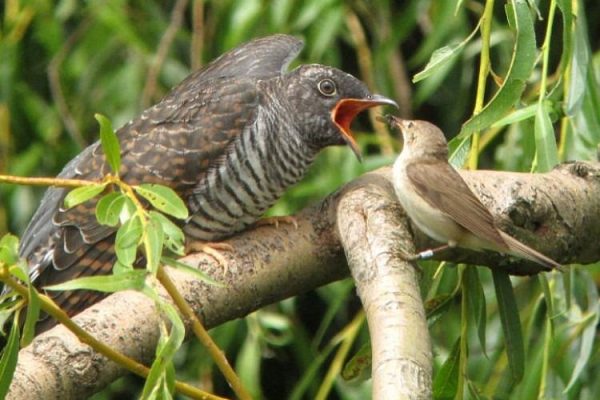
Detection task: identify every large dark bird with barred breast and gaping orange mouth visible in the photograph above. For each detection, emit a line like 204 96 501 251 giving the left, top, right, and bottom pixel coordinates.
14 35 395 331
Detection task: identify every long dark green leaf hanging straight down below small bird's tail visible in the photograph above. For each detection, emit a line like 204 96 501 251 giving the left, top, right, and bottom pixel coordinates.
492 269 525 383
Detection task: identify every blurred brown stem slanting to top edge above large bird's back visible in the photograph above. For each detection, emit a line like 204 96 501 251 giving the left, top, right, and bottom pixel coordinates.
142 0 188 108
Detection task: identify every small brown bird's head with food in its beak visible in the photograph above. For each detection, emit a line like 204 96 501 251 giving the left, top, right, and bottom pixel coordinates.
384 115 448 160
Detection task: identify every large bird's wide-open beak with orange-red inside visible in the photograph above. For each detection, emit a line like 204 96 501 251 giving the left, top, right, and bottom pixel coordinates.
331 94 398 160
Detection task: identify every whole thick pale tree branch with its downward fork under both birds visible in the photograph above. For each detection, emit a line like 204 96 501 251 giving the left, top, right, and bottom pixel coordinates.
9 163 600 399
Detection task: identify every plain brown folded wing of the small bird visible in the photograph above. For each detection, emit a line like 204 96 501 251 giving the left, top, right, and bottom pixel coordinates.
406 161 506 248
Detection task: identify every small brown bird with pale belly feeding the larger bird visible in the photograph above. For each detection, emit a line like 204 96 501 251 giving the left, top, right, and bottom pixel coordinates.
388 116 561 269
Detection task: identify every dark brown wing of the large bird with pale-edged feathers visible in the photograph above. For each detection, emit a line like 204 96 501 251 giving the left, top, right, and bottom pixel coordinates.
20 35 302 330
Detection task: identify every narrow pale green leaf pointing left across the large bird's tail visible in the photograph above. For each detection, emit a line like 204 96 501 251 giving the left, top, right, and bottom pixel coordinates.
44 269 148 293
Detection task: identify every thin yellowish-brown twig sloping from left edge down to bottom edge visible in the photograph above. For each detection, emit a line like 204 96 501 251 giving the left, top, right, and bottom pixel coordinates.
0 266 223 400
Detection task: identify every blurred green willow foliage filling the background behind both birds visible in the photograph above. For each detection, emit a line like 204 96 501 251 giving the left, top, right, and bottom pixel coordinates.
0 0 600 399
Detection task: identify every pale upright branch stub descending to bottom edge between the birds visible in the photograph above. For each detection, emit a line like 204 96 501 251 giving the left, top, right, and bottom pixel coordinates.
338 174 433 400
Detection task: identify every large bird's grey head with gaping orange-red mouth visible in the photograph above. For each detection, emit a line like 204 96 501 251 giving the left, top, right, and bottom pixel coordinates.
284 64 398 159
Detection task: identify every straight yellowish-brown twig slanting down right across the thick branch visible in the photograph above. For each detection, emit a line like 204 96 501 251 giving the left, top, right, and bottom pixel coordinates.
157 267 252 400
